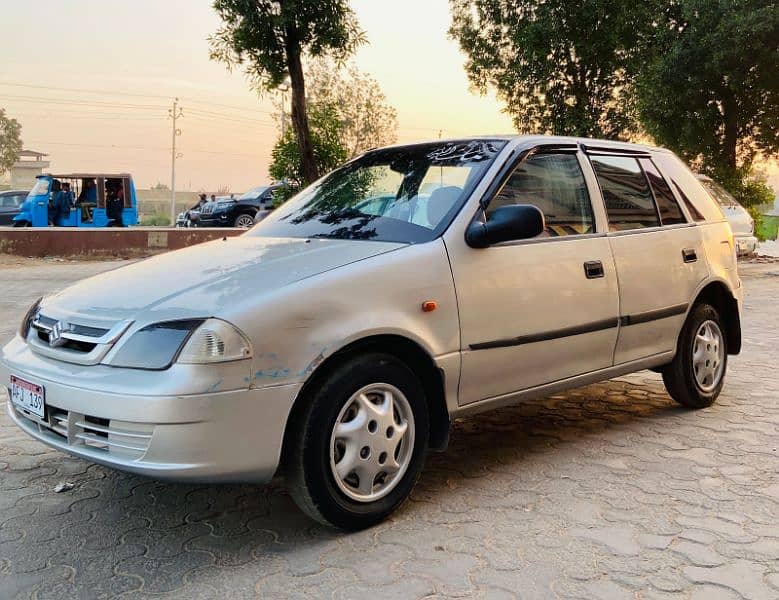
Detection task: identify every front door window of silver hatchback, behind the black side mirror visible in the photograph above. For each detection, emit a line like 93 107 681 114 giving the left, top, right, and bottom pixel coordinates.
486 154 595 237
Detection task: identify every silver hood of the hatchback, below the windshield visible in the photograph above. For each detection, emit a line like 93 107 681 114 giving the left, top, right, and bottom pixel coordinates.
41 235 404 326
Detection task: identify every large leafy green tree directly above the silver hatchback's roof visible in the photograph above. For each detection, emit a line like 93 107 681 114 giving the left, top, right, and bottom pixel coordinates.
449 0 652 138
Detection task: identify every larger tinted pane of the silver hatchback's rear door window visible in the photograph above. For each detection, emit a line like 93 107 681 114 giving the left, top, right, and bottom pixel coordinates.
590 156 660 231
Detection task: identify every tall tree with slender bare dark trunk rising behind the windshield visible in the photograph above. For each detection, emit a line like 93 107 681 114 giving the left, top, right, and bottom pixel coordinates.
209 0 365 182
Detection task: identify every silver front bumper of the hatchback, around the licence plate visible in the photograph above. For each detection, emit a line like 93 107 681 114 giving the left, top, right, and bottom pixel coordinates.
0 338 301 482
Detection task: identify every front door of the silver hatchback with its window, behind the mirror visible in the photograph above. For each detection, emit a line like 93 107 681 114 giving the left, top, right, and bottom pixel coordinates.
449 152 619 404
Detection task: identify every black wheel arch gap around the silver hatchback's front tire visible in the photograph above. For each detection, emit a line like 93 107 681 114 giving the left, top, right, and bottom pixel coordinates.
282 334 450 456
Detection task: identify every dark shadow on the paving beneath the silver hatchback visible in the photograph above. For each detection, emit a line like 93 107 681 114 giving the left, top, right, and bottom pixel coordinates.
0 373 682 591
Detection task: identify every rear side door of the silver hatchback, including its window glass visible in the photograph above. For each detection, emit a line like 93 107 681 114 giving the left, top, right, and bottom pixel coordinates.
589 154 707 364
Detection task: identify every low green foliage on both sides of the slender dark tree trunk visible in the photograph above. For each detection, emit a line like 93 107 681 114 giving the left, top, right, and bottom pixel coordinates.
268 102 348 190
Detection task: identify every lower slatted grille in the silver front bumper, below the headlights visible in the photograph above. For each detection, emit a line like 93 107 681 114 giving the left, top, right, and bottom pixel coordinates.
12 405 154 460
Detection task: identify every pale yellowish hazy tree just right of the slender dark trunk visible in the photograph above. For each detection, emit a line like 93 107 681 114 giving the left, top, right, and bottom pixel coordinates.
306 59 398 157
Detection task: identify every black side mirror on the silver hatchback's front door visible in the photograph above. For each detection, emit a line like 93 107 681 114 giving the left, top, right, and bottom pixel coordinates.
465 204 546 248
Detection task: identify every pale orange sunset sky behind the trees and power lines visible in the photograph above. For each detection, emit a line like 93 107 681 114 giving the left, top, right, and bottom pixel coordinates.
0 0 779 191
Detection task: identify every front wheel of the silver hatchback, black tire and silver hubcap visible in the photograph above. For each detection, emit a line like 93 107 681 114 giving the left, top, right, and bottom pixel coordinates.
282 353 429 531
